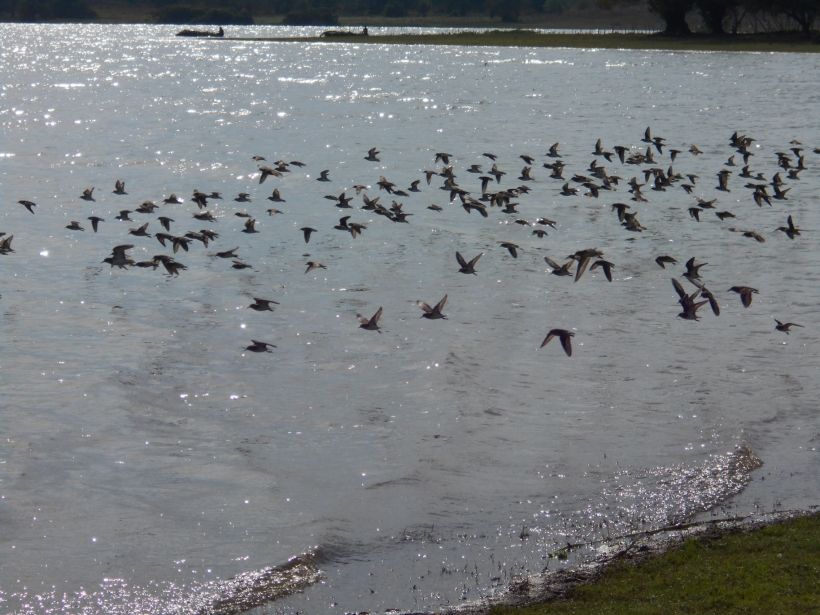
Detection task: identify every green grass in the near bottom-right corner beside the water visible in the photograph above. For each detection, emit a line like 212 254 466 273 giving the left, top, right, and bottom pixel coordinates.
490 516 820 615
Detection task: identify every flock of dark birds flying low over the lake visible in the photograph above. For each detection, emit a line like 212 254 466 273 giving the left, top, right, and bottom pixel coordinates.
0 128 820 356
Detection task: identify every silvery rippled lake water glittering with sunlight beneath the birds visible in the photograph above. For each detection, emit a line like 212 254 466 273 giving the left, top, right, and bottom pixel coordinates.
0 24 820 615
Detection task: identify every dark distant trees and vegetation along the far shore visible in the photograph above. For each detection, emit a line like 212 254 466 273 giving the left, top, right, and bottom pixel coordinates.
0 0 820 37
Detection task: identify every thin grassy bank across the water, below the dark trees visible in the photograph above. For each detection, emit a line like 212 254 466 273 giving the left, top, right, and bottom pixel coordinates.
240 30 820 53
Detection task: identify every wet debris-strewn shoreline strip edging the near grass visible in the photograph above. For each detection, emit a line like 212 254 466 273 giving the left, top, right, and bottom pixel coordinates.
454 510 820 615
